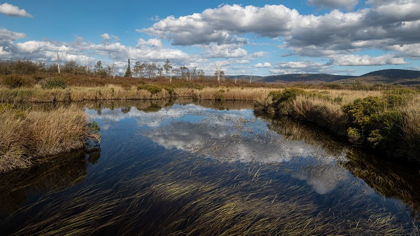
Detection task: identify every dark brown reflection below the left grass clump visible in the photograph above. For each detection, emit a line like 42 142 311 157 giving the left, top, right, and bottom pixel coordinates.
0 148 100 213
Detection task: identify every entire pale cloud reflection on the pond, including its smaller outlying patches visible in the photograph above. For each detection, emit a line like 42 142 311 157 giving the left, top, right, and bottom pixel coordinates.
88 104 349 194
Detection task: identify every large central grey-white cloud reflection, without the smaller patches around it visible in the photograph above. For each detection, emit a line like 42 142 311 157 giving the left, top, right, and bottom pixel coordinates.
145 114 344 166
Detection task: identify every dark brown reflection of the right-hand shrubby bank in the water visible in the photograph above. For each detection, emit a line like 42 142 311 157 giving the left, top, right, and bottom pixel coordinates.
260 114 420 223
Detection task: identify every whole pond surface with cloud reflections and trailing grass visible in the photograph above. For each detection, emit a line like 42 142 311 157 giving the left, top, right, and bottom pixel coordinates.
0 101 420 235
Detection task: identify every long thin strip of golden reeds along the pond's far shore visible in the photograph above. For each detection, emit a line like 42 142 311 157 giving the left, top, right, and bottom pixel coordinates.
0 84 273 103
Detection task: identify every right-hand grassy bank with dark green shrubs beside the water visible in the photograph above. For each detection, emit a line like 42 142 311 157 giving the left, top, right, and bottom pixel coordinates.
255 88 420 163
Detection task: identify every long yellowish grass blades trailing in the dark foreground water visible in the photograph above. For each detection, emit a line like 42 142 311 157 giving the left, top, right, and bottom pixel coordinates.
4 148 418 235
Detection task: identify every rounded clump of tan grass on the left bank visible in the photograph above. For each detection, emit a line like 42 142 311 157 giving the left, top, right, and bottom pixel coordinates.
0 104 99 173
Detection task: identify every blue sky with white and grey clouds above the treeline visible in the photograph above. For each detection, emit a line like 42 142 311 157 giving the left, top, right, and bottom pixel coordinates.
0 0 420 76
